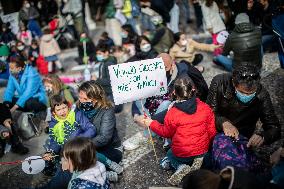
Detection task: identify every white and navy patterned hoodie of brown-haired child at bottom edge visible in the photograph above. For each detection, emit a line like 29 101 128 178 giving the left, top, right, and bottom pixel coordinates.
68 161 110 189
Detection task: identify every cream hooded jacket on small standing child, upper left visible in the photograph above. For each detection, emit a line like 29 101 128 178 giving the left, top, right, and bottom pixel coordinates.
39 34 60 57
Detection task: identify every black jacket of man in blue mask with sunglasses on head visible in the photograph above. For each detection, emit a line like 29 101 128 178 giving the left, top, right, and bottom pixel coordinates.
207 74 280 144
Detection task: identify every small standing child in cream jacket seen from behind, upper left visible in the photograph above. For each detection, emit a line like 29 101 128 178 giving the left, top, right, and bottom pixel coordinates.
39 28 64 73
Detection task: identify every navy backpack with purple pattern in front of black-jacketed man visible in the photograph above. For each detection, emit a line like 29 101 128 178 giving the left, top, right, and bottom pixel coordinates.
212 133 262 172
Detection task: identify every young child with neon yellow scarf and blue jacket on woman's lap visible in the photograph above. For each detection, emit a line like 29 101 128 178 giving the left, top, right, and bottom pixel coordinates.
44 95 123 181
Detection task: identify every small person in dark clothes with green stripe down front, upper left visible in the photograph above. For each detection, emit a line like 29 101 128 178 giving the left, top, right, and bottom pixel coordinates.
78 33 96 64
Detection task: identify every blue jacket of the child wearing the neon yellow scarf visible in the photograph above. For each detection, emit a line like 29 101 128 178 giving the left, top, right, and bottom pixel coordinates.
46 111 96 154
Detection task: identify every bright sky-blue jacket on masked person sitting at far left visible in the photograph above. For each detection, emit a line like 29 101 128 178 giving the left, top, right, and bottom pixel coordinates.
3 65 47 107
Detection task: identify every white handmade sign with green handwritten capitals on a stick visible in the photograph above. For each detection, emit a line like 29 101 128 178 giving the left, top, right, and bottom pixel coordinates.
108 58 167 105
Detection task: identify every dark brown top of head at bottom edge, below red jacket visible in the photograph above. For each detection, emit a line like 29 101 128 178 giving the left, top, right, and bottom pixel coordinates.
182 169 221 189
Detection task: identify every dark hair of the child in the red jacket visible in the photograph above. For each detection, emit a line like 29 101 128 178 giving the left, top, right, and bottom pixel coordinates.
173 75 195 100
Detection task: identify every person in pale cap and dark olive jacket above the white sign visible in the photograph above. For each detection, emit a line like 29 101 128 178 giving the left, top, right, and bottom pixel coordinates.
151 15 175 53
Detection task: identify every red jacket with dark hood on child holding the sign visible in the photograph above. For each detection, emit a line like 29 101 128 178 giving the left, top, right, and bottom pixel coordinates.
150 98 216 157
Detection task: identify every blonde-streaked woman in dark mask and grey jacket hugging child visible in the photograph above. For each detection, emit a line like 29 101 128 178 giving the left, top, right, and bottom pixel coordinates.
78 81 122 163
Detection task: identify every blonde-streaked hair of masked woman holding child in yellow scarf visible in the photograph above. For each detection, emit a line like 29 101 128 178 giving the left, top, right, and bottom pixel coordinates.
78 81 113 109
